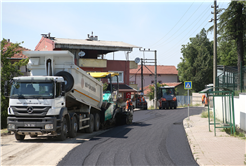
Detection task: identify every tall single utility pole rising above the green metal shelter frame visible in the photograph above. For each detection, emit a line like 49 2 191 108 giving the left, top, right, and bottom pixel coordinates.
209 0 219 87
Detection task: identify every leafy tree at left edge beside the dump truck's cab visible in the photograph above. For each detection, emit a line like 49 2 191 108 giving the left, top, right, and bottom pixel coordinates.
0 39 28 127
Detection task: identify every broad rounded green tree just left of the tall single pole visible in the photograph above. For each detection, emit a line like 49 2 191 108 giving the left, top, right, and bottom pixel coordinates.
178 28 213 92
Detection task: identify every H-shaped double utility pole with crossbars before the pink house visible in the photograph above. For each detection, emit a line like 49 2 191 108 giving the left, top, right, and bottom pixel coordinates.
139 48 157 109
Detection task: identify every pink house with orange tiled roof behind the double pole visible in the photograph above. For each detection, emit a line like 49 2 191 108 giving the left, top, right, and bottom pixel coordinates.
130 65 178 89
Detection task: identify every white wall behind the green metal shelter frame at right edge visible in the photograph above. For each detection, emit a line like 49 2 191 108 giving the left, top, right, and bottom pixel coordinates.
215 94 246 131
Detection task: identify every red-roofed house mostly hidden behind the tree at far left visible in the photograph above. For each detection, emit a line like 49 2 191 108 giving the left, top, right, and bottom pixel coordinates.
0 39 31 76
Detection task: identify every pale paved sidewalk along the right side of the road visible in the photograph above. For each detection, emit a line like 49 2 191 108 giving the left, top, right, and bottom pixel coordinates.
183 115 246 165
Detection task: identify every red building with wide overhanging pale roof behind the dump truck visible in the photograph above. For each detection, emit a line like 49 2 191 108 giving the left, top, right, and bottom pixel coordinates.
35 33 139 98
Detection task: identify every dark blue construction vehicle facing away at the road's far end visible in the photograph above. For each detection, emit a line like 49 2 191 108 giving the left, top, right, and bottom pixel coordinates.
158 86 177 109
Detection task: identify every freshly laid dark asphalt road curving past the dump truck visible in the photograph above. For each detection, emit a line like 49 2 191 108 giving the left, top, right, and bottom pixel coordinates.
58 107 203 166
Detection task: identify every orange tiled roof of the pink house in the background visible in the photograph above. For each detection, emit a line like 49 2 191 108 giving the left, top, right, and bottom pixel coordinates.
130 65 178 75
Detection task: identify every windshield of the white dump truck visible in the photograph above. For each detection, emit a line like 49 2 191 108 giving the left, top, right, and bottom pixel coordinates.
10 82 54 99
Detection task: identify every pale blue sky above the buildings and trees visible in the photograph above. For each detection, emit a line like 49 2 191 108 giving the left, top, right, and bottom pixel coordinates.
0 0 230 67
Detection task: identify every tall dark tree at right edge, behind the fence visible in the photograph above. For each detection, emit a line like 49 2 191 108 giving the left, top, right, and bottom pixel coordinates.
209 0 246 88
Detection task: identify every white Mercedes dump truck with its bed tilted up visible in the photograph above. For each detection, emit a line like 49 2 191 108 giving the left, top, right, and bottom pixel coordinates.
5 51 132 140
